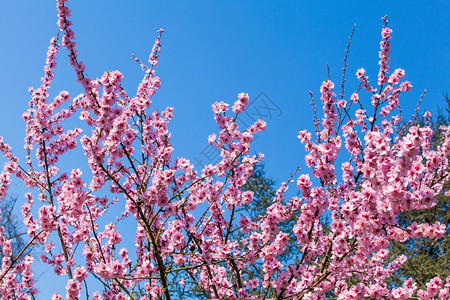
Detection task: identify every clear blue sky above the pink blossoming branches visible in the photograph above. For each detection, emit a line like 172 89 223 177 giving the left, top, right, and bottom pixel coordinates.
0 0 450 299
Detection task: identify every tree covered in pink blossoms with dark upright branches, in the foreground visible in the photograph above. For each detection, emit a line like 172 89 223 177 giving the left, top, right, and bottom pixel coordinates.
0 0 450 299
